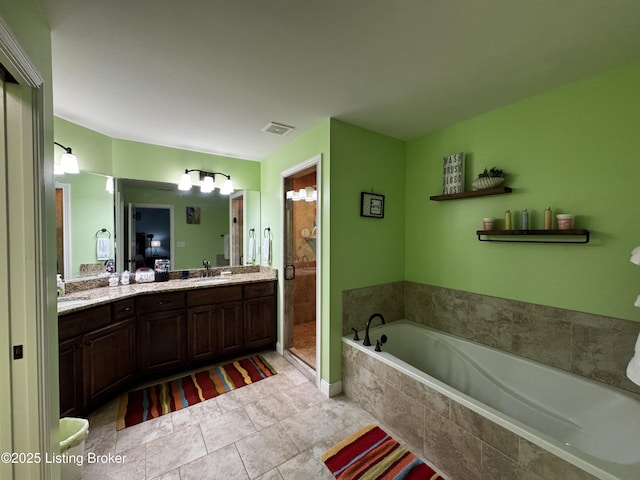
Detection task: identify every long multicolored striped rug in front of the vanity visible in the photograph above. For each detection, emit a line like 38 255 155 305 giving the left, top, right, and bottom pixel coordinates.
116 355 277 430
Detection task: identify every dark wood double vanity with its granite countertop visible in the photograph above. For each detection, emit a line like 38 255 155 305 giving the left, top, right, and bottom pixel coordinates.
58 267 277 416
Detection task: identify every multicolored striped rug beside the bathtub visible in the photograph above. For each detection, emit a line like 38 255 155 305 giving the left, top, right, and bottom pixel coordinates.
322 425 442 480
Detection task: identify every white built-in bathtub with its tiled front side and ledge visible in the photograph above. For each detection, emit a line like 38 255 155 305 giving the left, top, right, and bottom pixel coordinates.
343 321 640 480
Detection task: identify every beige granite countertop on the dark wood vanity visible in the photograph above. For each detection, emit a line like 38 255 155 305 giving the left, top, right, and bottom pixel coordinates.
58 267 278 314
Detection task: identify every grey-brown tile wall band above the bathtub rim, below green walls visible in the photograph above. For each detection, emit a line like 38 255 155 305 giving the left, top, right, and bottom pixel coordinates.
342 282 640 393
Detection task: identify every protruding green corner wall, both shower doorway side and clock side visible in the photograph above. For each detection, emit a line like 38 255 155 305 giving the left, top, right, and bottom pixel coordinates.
261 119 405 383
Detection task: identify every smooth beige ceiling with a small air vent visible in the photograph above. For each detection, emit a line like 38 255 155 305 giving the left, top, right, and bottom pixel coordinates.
39 0 640 160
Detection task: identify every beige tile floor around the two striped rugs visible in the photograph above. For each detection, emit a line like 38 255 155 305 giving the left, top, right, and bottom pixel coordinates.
82 352 430 480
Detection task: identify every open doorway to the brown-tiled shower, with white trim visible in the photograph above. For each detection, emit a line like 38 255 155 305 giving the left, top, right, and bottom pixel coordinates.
282 156 321 383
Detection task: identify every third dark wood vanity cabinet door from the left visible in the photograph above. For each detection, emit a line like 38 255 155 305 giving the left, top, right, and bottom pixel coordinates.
138 310 187 374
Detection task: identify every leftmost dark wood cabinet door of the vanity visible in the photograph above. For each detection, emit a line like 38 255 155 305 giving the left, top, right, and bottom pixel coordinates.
58 337 83 417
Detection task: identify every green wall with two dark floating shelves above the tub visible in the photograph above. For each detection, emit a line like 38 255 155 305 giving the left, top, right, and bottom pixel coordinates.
405 63 640 320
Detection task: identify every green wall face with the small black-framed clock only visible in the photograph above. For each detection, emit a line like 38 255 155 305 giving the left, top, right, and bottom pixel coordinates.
330 120 405 382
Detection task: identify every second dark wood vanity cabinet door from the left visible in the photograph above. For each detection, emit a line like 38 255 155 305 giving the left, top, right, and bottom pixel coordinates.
82 319 135 405
